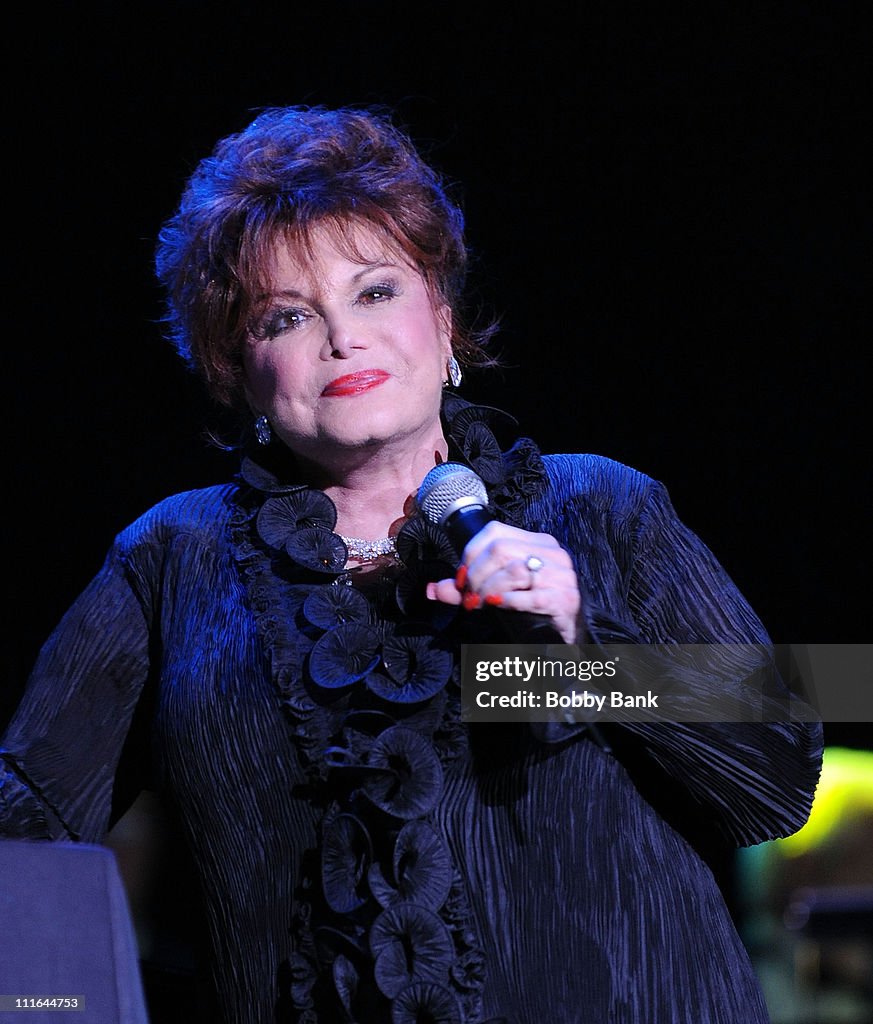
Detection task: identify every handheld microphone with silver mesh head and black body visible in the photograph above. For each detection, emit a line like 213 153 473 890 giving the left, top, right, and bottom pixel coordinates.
416 462 564 643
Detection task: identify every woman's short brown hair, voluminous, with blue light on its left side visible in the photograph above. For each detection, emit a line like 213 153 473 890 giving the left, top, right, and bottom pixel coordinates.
156 106 493 406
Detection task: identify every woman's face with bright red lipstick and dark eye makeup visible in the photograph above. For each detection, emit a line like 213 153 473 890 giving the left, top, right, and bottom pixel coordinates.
244 224 451 465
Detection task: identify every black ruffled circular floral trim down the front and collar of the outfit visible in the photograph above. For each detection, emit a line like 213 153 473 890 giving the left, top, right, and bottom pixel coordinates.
231 396 545 1024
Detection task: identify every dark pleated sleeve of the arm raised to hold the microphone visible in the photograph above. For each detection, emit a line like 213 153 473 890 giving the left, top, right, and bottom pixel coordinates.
532 456 822 846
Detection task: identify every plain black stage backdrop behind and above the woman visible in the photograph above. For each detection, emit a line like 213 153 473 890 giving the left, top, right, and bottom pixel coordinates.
0 0 871 753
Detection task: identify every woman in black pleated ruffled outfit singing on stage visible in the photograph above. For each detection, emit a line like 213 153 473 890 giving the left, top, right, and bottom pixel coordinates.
0 108 821 1024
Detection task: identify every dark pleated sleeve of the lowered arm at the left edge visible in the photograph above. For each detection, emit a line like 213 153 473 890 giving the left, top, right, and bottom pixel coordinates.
0 542 150 843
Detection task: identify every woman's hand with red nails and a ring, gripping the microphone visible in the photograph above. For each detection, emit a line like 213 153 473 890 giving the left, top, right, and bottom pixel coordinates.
427 522 582 643
